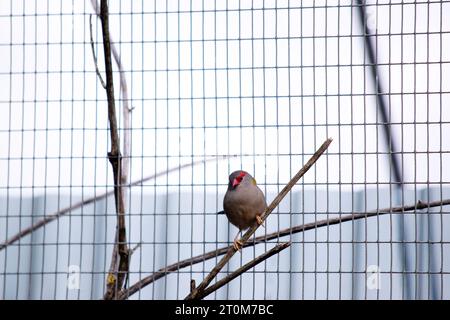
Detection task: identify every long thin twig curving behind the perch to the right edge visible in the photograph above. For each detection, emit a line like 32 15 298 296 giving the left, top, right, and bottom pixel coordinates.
119 199 450 299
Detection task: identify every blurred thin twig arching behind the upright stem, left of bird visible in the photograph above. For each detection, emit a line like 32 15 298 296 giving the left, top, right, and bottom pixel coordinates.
0 155 232 251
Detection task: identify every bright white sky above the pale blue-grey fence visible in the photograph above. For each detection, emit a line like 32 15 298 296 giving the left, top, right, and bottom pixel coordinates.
0 0 450 193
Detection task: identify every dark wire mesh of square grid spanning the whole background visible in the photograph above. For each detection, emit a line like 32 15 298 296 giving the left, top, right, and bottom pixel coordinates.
0 0 450 299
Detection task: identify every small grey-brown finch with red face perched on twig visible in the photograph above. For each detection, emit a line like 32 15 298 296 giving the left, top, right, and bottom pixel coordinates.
223 170 267 251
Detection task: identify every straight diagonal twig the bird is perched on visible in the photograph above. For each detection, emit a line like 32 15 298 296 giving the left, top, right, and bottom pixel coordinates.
186 138 333 300
